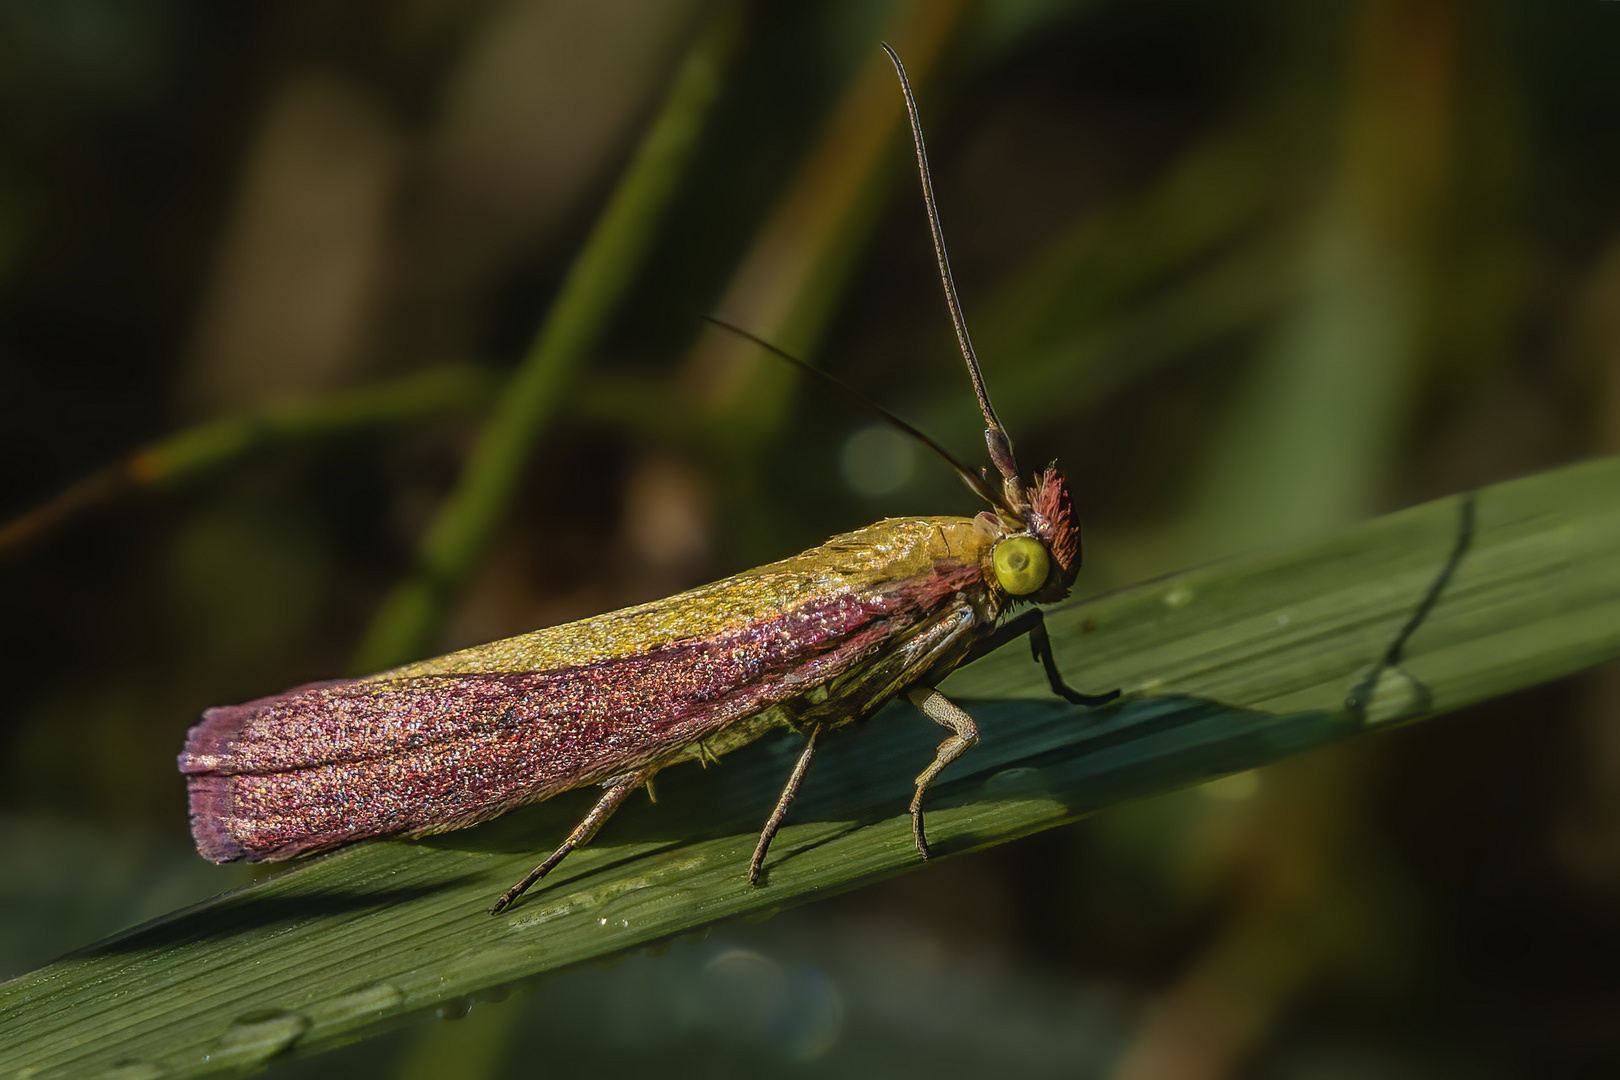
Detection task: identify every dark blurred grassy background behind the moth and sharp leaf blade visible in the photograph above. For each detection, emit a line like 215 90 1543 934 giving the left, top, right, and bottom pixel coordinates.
0 0 1620 1080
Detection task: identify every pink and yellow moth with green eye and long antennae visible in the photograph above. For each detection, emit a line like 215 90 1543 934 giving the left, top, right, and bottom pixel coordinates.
180 45 1116 913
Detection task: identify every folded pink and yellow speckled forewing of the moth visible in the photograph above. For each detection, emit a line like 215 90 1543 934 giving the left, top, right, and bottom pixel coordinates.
180 518 993 861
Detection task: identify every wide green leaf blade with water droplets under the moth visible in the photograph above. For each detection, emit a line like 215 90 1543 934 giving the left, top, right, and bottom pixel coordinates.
0 458 1620 1077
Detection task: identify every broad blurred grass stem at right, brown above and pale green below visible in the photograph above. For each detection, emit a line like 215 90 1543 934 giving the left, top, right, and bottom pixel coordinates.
1181 0 1458 559
